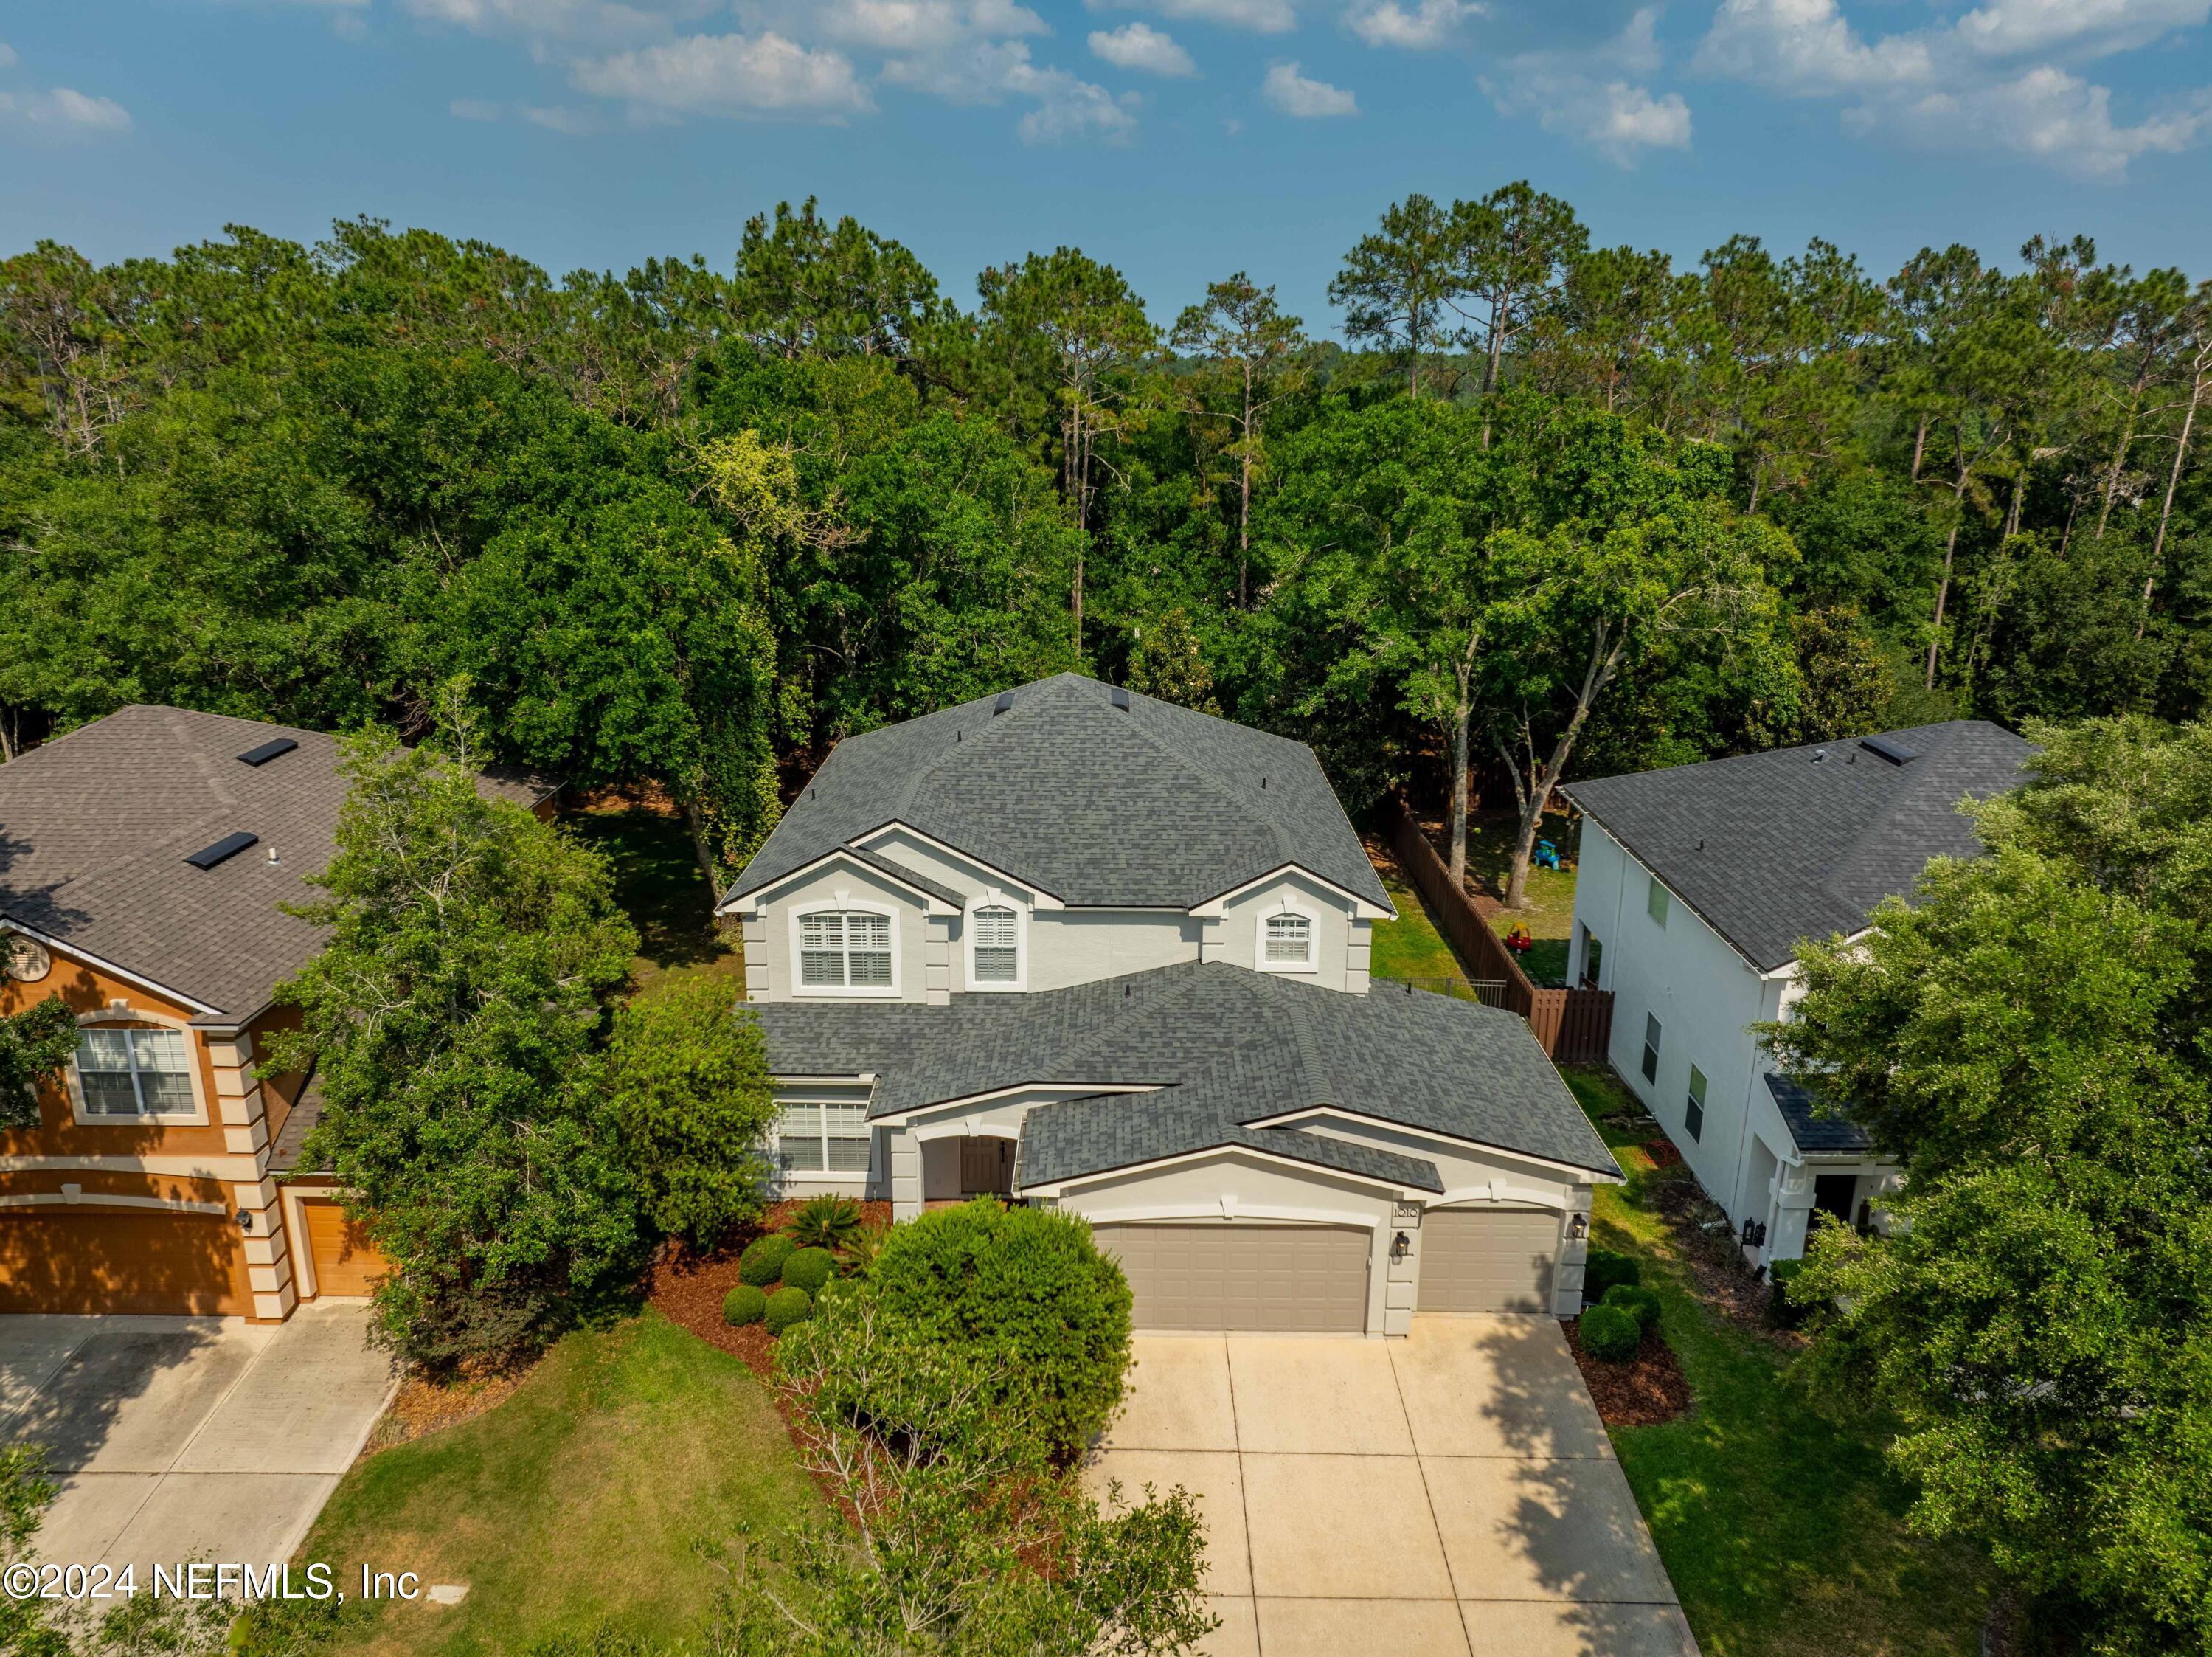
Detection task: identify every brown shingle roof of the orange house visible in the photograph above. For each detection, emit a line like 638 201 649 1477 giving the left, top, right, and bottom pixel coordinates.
0 706 555 1017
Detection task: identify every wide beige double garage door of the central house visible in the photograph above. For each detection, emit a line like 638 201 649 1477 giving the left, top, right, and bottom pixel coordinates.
1098 1221 1369 1334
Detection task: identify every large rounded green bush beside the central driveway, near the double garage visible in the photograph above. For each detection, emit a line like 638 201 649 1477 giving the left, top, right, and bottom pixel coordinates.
870 1201 1130 1456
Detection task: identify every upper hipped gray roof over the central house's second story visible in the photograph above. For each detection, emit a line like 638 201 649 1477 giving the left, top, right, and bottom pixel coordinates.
728 673 1389 909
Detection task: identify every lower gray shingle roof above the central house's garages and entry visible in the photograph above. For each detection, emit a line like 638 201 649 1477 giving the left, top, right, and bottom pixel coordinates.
748 962 1615 1183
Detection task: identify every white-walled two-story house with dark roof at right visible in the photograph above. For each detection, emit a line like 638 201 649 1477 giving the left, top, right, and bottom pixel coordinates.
1561 719 2031 1261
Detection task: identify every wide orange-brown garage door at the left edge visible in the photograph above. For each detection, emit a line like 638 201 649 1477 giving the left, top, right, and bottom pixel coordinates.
0 1208 254 1316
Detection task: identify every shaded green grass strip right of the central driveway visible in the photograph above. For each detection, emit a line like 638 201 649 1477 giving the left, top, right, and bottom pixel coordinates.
1566 1070 1991 1657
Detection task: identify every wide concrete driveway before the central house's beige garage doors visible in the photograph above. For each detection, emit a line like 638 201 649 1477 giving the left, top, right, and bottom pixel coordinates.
1089 1316 1696 1657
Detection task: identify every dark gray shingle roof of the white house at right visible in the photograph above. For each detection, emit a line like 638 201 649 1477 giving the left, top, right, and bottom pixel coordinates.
1561 719 2033 971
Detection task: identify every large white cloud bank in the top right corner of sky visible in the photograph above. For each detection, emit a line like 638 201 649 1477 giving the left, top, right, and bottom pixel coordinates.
1696 0 2212 179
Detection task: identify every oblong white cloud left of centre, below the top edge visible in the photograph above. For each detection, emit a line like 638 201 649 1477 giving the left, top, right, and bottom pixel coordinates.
571 33 874 122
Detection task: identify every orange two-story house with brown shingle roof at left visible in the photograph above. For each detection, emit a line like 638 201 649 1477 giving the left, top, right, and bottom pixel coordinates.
0 706 551 1321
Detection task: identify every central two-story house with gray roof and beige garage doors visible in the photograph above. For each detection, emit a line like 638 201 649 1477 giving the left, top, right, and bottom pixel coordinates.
721 675 1617 1334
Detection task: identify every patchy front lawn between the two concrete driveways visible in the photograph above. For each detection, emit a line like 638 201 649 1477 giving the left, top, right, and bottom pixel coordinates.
303 1310 821 1657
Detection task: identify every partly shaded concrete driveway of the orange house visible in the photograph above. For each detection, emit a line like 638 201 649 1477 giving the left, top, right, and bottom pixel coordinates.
0 1301 398 1580
